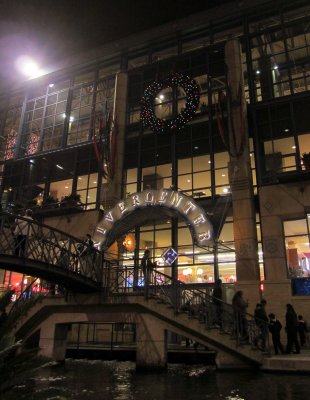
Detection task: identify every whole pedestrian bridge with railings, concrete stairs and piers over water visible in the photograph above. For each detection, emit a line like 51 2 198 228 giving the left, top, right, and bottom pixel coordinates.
0 213 272 365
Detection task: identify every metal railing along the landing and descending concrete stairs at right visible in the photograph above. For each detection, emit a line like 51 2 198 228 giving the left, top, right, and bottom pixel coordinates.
103 266 270 353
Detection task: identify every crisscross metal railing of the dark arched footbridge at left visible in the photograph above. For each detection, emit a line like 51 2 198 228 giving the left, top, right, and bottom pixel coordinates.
0 213 106 283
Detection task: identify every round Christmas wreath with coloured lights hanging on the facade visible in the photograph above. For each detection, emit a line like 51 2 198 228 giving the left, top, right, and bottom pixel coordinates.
141 73 199 133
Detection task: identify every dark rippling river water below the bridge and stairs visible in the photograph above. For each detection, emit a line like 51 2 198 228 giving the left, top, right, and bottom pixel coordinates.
1 359 310 400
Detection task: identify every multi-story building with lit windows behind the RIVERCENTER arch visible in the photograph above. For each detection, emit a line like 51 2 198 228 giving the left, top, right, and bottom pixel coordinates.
1 0 310 318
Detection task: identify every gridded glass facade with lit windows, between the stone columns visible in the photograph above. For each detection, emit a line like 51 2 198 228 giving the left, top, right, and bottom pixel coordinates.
1 0 310 290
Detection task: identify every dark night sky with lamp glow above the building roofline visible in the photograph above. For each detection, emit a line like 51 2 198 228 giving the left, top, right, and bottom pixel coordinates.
0 0 228 83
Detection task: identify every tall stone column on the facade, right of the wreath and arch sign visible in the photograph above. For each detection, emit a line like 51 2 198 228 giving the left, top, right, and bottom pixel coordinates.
225 39 260 304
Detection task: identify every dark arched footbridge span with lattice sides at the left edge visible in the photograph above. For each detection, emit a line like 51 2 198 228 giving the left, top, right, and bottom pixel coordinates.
0 213 108 293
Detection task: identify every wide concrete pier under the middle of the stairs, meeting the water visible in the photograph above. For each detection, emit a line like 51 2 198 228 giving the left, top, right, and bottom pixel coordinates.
136 314 167 370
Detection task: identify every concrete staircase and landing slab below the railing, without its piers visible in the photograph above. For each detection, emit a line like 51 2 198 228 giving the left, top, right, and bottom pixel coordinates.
10 293 266 368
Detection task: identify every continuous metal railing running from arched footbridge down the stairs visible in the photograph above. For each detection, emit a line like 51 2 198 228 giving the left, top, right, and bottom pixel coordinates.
0 213 270 352
